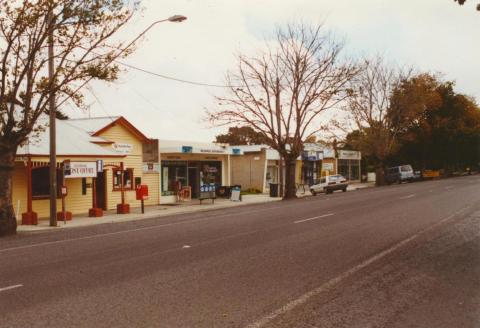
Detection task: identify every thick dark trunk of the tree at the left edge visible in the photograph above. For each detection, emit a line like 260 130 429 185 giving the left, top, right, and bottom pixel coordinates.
0 148 17 237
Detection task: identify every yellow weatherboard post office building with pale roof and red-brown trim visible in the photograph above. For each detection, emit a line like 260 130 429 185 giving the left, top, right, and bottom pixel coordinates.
13 117 159 224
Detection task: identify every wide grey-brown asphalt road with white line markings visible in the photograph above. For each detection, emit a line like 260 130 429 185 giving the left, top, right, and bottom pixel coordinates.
0 176 480 328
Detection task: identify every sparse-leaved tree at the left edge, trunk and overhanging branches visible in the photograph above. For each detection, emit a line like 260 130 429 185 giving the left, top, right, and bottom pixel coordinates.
0 0 137 235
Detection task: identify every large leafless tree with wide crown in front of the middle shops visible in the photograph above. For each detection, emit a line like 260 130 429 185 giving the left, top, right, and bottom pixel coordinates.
208 24 357 198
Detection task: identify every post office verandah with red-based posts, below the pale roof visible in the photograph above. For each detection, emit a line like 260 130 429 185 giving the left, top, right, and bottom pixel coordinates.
13 156 133 224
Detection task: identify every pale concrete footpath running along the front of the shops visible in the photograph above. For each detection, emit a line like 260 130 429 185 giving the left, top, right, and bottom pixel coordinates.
17 183 374 233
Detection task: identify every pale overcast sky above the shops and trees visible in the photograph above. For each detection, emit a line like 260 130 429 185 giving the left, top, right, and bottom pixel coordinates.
64 0 480 141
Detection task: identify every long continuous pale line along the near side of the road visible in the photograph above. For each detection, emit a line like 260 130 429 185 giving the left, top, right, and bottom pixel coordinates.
247 205 472 328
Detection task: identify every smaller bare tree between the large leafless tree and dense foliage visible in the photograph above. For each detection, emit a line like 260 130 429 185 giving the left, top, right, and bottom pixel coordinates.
335 56 411 184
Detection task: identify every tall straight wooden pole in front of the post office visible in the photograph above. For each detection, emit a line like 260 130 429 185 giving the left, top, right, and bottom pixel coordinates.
47 9 57 227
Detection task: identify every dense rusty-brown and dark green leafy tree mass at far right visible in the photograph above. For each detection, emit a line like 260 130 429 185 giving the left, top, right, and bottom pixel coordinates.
392 74 480 172
